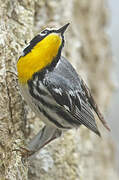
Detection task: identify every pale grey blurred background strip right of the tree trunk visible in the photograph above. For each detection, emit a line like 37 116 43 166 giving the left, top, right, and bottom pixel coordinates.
108 0 119 170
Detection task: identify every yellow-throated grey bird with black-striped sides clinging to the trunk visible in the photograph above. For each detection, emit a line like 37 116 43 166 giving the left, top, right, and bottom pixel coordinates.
17 23 110 155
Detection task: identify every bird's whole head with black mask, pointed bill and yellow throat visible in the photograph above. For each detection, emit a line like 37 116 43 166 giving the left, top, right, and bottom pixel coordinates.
17 23 69 83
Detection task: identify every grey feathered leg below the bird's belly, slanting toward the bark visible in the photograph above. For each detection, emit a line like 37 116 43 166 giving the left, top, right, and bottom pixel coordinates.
27 126 62 156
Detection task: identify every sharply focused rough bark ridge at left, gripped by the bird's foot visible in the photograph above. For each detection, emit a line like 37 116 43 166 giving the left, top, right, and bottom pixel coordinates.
0 0 34 180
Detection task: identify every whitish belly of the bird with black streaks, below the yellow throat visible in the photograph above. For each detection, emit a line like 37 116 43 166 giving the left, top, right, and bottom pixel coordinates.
20 85 73 129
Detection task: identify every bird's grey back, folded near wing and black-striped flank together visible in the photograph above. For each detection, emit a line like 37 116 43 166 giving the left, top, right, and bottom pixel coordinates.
28 57 100 135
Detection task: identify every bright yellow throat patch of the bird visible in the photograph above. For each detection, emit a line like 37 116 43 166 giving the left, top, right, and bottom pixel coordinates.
17 33 62 84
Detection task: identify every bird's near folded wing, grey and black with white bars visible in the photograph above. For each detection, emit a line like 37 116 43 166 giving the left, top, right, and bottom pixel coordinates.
45 72 100 136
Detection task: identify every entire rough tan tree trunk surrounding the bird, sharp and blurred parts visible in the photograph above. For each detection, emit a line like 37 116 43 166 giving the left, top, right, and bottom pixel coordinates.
0 0 118 180
